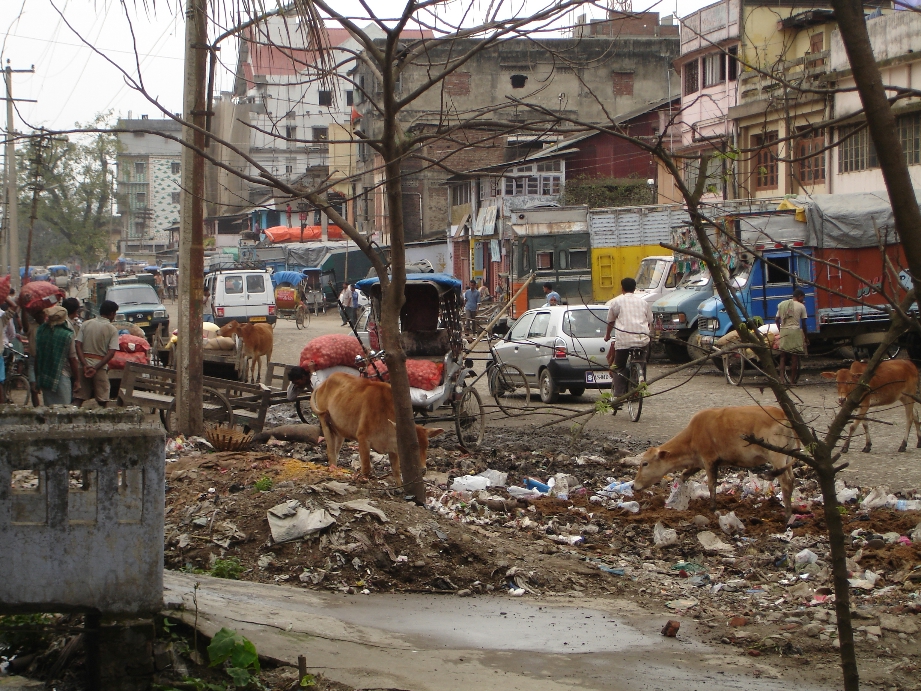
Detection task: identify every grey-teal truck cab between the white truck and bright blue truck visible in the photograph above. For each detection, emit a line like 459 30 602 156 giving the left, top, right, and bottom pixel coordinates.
652 267 713 362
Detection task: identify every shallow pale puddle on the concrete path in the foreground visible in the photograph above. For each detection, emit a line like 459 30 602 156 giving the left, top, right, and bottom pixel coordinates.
325 595 661 653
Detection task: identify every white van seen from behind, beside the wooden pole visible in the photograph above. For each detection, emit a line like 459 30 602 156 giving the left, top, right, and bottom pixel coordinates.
205 268 277 326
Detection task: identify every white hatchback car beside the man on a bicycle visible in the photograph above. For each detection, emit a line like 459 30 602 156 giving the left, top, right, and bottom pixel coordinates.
495 305 614 403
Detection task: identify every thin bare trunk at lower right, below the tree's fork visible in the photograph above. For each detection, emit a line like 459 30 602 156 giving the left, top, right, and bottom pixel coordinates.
816 464 860 691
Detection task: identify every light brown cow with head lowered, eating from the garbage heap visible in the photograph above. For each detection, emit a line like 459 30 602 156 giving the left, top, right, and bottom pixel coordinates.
633 406 798 519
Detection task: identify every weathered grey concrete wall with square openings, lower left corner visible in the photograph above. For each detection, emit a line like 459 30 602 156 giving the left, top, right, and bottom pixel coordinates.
0 406 164 615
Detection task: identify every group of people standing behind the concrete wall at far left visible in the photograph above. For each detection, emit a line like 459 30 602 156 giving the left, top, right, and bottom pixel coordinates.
0 293 119 407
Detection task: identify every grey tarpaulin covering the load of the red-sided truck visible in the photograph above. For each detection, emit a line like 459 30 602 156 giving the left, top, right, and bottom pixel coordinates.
795 190 904 249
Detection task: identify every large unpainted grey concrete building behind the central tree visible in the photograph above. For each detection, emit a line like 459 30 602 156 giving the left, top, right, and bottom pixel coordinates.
354 12 678 244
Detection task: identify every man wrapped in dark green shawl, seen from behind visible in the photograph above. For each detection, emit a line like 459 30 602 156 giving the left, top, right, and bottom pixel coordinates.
35 305 78 405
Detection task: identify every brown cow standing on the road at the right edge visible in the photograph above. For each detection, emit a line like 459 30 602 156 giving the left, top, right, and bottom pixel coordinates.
822 360 921 453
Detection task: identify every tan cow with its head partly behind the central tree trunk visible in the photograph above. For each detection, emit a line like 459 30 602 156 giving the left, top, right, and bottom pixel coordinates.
310 372 444 485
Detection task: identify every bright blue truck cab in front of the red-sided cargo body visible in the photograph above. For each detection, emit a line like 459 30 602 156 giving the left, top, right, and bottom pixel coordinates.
700 247 818 348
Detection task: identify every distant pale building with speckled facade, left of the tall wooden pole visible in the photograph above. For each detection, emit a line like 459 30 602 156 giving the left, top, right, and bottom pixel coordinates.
116 112 182 256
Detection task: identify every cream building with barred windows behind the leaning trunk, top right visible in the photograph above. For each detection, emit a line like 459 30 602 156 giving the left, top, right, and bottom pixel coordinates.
828 11 921 194
